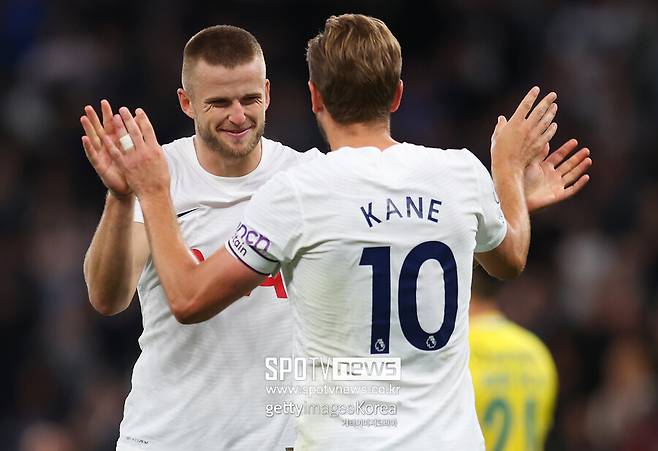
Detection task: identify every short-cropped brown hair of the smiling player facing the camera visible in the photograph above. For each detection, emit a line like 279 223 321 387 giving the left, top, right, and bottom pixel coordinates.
182 25 263 87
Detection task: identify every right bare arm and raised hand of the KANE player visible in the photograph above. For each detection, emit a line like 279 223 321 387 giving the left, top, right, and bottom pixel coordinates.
475 87 557 279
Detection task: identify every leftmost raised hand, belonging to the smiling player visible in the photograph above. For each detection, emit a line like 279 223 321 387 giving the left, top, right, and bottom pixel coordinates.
80 100 132 197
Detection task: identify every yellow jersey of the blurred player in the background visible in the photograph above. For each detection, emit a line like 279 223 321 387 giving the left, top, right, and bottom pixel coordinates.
470 313 557 451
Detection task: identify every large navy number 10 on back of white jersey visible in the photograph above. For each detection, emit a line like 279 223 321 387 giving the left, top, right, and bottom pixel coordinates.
359 241 457 354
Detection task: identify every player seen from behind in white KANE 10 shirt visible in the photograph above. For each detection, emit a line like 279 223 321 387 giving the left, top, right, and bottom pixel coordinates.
105 15 586 450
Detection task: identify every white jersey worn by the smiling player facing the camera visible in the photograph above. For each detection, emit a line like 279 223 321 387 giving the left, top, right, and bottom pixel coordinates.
117 137 321 451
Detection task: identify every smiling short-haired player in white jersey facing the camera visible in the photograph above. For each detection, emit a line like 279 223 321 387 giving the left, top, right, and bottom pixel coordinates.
82 26 319 451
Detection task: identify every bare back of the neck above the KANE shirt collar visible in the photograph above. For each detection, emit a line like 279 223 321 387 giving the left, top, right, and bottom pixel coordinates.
324 121 398 150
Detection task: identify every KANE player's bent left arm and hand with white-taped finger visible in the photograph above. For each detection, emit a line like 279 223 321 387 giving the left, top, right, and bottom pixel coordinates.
99 108 267 323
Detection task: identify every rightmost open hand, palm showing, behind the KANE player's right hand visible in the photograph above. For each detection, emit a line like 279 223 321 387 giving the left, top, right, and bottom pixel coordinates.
524 139 592 212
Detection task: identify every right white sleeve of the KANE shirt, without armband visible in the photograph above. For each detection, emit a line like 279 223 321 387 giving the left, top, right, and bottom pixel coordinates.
469 152 507 253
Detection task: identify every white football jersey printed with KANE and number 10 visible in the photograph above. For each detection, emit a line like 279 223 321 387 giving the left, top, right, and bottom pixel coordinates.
226 143 507 451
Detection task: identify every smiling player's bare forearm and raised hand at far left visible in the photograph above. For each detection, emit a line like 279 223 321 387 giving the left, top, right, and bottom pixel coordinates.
80 100 149 315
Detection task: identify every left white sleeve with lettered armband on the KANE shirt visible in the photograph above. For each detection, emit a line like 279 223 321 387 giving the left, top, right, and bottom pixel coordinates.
225 173 302 274
